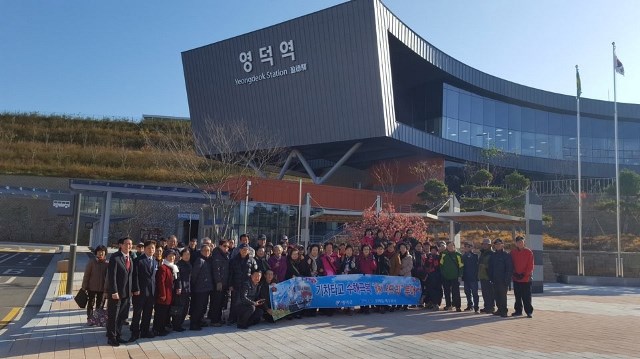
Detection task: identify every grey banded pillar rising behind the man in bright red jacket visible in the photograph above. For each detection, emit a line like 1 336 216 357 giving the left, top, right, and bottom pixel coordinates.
524 191 544 293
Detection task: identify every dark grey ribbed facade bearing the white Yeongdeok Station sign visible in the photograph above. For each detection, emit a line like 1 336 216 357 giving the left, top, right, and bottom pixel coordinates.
182 1 385 151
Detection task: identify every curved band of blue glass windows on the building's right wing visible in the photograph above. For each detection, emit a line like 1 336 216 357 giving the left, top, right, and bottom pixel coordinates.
442 84 640 163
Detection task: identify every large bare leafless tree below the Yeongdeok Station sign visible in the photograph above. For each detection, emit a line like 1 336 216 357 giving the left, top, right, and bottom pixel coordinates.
142 121 282 238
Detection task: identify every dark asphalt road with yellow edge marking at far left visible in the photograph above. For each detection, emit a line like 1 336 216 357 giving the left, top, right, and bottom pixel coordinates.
0 251 53 329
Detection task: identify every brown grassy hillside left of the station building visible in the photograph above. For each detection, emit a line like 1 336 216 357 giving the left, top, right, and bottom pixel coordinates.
0 113 195 182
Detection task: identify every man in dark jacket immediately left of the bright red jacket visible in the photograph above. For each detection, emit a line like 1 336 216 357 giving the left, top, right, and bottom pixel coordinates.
489 238 513 318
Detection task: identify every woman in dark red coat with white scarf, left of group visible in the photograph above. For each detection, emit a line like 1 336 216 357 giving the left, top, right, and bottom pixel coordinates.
153 249 180 336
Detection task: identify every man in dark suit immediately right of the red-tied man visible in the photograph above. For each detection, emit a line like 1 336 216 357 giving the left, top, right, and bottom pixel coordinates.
129 241 158 342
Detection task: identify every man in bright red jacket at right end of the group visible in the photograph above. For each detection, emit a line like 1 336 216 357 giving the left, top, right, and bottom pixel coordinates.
510 236 534 318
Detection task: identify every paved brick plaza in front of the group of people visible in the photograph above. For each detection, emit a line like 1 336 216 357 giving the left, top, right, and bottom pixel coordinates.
0 253 640 359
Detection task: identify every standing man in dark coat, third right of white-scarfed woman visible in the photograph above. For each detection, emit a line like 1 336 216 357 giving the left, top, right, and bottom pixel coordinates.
208 239 229 327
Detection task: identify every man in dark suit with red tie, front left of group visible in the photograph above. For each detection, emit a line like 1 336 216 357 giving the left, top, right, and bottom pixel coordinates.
107 237 133 347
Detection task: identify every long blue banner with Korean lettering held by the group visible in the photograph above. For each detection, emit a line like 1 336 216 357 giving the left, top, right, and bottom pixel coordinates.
270 274 422 319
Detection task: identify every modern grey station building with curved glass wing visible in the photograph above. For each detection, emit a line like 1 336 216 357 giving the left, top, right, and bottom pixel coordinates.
182 0 640 240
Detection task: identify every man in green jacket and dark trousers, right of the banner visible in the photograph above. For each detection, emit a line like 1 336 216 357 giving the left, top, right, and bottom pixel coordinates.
440 241 464 312
